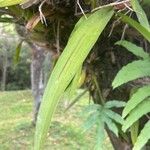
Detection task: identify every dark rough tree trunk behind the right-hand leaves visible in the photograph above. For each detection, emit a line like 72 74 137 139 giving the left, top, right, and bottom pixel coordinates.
85 35 137 150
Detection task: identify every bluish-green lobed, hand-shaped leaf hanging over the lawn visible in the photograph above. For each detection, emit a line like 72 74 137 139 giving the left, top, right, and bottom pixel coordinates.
83 101 125 150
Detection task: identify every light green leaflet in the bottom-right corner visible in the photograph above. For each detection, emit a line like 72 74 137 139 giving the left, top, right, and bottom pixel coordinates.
133 121 150 150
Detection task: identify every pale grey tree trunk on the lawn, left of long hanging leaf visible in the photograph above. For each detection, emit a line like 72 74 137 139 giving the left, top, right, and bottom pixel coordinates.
29 43 45 124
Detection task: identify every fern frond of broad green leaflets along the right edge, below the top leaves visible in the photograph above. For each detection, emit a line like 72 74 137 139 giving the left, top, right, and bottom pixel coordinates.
112 41 150 150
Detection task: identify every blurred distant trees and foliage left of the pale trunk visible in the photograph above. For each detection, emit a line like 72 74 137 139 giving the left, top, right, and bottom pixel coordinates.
0 23 31 90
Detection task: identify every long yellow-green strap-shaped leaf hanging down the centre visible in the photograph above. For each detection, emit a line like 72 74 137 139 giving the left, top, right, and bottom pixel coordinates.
34 8 113 150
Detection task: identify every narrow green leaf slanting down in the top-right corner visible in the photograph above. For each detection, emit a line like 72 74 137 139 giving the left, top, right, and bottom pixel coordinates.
131 0 150 31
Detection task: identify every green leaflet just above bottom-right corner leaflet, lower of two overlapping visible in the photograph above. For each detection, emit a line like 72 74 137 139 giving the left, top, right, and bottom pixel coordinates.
122 99 150 131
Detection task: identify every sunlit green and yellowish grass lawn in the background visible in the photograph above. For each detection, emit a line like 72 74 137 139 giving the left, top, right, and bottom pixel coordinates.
0 91 112 150
